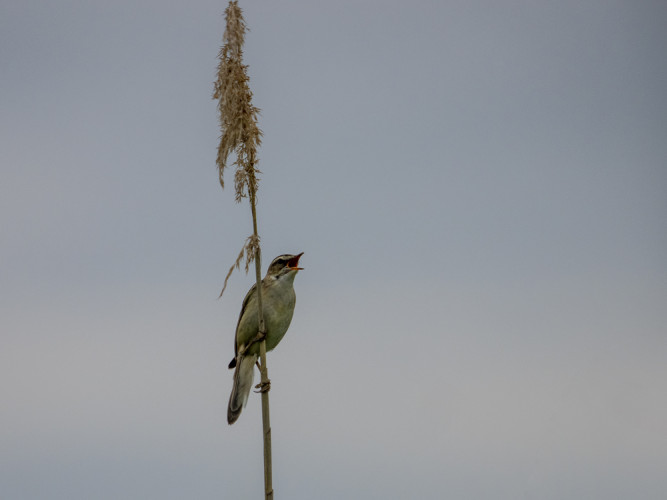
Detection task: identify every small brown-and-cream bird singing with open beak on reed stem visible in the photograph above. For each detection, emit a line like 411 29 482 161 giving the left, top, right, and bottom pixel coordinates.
227 252 303 425
